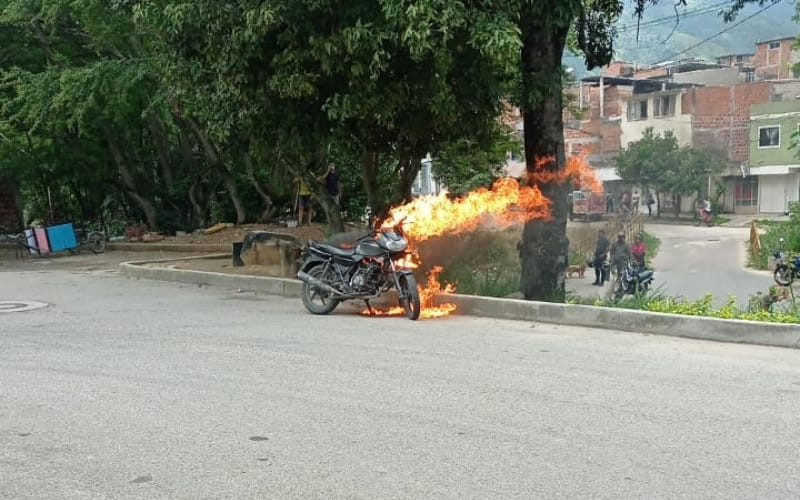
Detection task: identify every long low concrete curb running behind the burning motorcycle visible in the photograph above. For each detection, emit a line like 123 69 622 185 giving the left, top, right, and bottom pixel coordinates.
120 255 800 348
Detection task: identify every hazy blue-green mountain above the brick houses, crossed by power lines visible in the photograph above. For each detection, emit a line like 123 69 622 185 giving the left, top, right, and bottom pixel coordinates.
564 0 800 77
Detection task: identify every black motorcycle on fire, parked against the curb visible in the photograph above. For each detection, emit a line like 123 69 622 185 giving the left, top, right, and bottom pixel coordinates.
297 223 421 320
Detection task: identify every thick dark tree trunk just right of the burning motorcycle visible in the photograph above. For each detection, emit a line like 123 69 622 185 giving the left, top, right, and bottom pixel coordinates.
519 21 569 302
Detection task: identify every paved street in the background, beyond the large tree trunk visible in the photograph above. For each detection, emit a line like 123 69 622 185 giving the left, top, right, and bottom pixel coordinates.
567 224 774 307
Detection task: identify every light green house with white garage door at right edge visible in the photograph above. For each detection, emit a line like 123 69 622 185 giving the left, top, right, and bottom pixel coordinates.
734 100 800 213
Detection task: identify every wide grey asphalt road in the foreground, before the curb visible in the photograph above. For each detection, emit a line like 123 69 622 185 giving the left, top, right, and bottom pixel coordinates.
0 260 800 499
